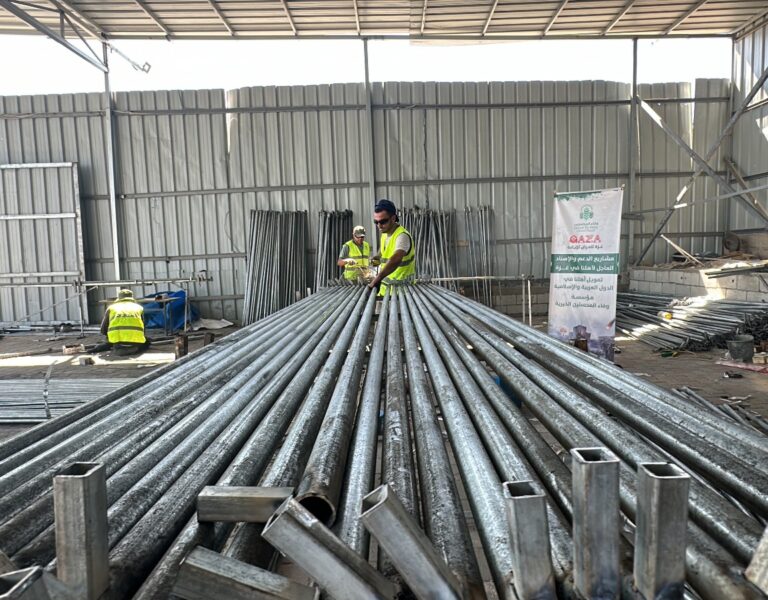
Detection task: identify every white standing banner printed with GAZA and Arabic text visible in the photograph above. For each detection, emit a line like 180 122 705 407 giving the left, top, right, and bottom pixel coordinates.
549 188 624 360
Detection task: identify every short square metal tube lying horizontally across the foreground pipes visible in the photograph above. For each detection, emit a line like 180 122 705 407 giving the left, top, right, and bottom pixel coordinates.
197 485 293 523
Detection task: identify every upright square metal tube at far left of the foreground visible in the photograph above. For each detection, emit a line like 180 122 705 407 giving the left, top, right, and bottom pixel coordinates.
53 463 109 600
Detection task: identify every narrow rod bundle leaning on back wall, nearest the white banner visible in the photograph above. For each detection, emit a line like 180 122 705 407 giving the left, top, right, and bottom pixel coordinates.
464 206 496 306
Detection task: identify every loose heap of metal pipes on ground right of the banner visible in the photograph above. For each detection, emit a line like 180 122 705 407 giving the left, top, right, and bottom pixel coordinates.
616 292 768 352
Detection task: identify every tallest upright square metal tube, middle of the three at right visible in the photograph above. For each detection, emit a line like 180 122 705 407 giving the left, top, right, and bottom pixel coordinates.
571 448 621 600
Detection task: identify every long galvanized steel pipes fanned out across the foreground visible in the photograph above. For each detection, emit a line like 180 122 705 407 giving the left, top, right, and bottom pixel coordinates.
0 284 768 600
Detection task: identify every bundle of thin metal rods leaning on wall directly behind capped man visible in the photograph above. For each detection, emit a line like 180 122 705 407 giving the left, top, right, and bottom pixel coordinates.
400 207 457 287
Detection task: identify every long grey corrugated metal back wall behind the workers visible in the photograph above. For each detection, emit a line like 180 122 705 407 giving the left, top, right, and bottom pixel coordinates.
0 80 728 320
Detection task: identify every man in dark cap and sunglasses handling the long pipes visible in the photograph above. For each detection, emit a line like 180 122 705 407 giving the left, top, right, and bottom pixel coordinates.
368 200 416 296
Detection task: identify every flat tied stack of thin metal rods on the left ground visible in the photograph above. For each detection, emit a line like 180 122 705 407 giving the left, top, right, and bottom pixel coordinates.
0 377 133 423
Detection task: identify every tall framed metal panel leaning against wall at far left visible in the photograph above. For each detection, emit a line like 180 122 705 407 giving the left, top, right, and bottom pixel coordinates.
0 163 88 323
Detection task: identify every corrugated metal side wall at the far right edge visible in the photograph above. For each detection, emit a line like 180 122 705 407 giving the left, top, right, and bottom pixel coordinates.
729 25 768 230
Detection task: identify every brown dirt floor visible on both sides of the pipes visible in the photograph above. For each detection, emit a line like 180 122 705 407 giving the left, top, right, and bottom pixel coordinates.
0 323 768 440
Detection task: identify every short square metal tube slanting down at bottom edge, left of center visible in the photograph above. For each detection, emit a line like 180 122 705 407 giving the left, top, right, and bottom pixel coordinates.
173 546 319 600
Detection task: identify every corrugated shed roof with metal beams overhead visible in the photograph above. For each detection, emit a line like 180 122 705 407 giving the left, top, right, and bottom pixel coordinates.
0 0 768 39
